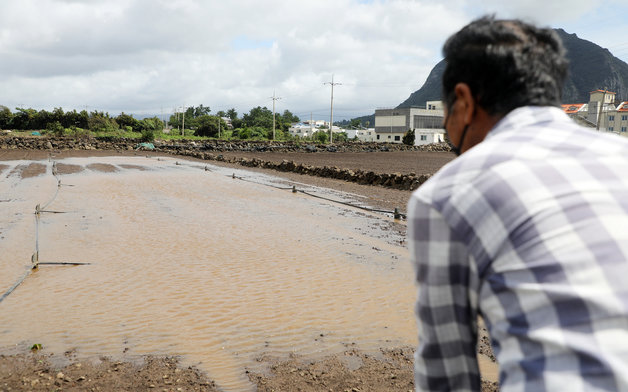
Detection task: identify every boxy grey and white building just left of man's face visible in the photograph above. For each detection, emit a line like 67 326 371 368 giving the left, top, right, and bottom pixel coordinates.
375 101 445 145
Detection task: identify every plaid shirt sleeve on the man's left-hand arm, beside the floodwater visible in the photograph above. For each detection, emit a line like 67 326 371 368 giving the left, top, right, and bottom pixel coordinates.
408 197 481 391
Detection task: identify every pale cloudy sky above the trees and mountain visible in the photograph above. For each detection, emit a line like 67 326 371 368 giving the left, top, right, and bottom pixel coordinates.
0 0 628 119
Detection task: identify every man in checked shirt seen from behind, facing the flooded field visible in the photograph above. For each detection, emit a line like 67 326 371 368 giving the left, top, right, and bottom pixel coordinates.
408 17 628 391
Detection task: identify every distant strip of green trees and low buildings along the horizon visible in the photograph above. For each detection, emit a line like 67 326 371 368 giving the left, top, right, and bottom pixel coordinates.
0 90 628 145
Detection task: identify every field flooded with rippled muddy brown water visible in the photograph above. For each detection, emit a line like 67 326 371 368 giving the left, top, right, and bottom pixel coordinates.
0 156 416 391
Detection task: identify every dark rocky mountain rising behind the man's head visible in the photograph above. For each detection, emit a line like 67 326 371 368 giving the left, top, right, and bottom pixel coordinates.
397 29 628 108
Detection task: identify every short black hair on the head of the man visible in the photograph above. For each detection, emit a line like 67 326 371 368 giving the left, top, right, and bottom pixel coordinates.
443 16 568 115
